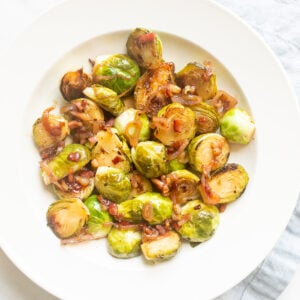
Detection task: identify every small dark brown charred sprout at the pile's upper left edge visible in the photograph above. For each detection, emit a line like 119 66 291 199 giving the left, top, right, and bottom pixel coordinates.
60 68 92 101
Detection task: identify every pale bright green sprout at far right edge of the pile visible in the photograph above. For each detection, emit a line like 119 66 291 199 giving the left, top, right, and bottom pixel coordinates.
220 107 255 144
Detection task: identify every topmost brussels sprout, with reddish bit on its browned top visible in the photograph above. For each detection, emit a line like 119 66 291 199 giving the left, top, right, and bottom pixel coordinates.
126 28 162 69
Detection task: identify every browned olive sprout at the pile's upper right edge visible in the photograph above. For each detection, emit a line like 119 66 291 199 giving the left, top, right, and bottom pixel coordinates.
176 62 217 101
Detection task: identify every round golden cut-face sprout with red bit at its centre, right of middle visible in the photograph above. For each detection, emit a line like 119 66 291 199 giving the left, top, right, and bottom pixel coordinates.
152 103 196 146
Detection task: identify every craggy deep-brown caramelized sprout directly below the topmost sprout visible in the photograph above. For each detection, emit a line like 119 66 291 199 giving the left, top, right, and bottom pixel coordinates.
134 63 175 117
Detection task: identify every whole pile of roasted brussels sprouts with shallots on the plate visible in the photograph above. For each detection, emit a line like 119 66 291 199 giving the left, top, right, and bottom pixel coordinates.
32 28 255 263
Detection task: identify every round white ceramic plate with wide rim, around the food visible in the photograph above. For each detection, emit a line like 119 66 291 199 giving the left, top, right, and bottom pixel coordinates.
0 0 300 299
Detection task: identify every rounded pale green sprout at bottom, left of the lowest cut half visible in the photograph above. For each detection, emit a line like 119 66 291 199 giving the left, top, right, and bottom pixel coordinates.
107 228 142 258
